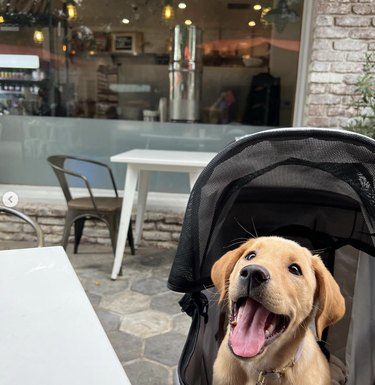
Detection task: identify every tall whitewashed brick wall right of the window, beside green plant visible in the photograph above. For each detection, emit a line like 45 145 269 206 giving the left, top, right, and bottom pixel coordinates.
305 0 375 127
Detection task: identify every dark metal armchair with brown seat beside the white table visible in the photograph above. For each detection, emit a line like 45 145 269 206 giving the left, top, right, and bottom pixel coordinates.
47 155 135 255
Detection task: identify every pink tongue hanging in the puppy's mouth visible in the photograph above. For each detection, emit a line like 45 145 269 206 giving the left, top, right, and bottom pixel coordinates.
230 298 270 357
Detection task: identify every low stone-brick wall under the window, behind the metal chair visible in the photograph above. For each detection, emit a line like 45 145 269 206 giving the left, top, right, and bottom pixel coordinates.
0 202 183 250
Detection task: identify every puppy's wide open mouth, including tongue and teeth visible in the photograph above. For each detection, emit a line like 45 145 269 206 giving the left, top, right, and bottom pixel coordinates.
229 298 289 357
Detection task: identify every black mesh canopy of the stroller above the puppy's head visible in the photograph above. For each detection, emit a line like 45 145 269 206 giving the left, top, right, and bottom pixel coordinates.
168 128 375 293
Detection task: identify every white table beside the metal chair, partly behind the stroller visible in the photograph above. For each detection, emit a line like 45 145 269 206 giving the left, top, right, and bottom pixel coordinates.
111 150 216 279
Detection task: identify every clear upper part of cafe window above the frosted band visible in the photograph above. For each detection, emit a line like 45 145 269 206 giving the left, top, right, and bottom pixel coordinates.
0 0 303 127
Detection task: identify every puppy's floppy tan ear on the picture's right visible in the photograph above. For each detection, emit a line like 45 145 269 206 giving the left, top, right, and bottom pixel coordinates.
313 255 345 339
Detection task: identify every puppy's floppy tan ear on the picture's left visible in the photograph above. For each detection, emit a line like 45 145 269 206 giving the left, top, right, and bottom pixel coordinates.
211 243 248 303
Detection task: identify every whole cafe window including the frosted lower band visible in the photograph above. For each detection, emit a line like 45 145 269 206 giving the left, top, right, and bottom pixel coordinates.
0 0 304 193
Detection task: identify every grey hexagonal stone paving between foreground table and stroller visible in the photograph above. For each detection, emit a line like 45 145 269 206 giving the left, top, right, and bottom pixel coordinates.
1 243 190 385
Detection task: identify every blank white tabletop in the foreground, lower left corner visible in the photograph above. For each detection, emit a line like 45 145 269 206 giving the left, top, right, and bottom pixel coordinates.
0 246 130 385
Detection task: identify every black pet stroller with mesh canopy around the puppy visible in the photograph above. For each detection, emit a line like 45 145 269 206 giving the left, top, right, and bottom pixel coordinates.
168 128 375 385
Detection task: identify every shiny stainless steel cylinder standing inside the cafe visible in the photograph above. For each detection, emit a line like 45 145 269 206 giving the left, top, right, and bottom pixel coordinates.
169 25 202 122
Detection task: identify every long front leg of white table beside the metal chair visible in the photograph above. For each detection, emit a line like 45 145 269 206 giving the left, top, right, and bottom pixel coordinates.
111 164 138 279
